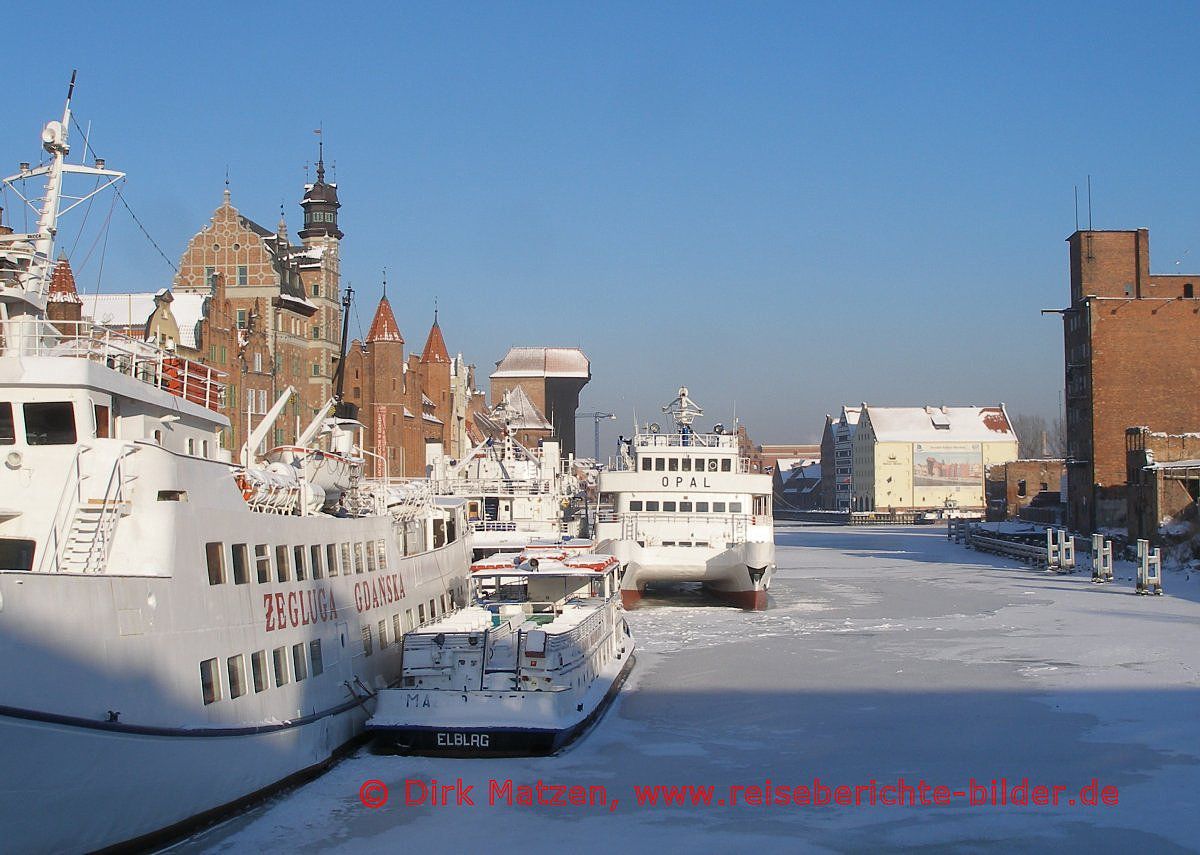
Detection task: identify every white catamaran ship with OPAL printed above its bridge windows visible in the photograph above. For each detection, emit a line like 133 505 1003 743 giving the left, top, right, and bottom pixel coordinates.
596 387 775 609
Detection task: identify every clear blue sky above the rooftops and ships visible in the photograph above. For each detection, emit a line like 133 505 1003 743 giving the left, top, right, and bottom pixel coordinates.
0 2 1200 449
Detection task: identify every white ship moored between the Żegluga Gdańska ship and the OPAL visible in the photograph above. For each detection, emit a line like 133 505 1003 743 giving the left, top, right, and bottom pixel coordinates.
428 402 586 558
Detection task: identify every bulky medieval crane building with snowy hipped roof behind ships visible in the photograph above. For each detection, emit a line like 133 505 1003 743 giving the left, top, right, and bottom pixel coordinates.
491 347 592 456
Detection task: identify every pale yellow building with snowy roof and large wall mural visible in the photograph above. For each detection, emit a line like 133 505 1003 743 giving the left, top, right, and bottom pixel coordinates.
852 403 1018 510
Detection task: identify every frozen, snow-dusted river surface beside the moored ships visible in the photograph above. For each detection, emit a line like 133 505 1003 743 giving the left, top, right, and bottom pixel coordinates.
172 526 1200 854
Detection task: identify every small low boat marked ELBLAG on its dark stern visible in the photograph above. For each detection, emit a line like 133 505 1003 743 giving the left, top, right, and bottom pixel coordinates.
366 542 634 757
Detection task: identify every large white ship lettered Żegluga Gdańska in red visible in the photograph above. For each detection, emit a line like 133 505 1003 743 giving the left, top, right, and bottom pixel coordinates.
0 80 469 853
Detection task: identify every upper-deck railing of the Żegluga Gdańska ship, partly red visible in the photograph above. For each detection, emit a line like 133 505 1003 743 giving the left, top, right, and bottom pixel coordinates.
0 319 226 411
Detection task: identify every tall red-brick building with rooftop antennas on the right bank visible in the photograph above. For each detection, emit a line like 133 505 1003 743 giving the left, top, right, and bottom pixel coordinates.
1062 228 1200 532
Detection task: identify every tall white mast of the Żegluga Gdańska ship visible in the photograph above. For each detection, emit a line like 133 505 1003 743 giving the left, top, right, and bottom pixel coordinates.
0 71 125 319
